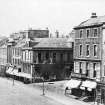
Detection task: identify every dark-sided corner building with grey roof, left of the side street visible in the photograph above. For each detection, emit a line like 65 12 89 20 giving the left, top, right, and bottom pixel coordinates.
22 38 73 82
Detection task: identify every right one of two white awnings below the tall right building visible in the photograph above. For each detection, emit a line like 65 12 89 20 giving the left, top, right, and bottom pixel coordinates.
80 80 97 91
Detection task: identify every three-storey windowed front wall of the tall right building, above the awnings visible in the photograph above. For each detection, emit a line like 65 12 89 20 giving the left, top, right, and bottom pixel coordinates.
74 26 102 79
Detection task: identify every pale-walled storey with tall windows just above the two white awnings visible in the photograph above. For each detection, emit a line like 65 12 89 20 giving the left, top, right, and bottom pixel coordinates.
74 59 101 79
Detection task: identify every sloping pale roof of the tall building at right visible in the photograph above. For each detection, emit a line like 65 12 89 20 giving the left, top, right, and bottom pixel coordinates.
74 16 105 29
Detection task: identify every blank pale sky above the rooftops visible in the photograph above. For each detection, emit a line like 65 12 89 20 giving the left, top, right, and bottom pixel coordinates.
0 0 105 36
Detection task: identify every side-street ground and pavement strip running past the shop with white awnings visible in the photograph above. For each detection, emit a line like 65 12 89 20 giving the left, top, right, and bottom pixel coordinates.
29 80 95 105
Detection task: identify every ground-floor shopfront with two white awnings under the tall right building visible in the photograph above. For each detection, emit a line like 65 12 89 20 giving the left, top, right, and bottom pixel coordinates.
66 73 97 101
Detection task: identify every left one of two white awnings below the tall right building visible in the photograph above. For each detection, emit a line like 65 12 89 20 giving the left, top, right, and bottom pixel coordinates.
66 79 81 89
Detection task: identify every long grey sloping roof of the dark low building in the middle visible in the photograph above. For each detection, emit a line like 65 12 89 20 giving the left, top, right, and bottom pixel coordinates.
33 38 73 48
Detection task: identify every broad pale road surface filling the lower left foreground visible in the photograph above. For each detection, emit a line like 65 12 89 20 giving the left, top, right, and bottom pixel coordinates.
0 78 89 105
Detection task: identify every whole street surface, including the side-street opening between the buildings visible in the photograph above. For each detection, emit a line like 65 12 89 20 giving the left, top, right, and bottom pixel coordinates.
0 77 97 105
